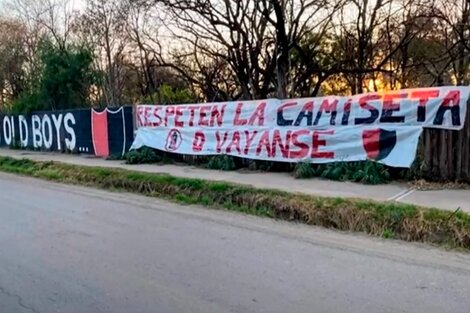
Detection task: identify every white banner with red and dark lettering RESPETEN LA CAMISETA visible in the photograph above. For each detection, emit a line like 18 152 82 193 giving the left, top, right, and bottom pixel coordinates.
132 87 470 167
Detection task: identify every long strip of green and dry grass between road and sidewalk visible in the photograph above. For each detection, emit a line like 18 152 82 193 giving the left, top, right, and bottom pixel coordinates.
0 157 470 249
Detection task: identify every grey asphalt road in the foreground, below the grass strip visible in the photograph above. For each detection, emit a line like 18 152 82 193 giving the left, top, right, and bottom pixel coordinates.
0 174 470 313
